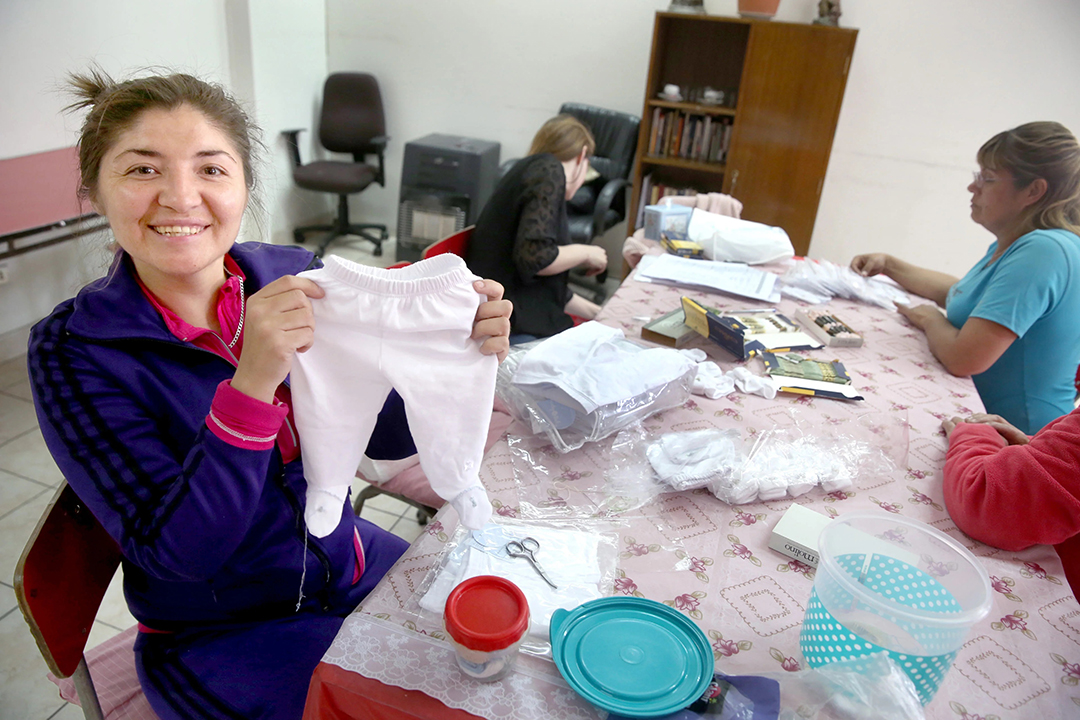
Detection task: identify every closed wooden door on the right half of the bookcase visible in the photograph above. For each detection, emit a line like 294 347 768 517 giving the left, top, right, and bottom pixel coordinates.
724 23 858 255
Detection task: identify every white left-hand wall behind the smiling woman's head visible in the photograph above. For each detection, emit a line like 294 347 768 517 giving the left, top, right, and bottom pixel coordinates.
0 0 329 359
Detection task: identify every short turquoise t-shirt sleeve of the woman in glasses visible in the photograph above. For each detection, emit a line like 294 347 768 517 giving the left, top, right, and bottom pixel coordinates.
971 232 1070 337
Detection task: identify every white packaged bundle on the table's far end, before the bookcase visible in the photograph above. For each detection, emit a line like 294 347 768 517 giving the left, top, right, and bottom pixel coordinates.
687 209 795 264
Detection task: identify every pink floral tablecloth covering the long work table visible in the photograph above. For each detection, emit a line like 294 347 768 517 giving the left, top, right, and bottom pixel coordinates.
323 272 1080 720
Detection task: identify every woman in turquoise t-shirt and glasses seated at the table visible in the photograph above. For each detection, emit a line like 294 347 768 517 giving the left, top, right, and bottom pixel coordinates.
851 122 1080 434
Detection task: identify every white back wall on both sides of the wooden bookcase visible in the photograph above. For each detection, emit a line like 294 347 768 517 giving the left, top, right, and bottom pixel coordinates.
326 0 1080 274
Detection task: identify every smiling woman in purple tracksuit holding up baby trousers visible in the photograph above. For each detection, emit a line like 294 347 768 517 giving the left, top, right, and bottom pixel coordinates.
28 71 510 719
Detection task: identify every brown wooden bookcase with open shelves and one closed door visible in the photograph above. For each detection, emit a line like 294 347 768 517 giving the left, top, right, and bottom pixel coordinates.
631 12 859 255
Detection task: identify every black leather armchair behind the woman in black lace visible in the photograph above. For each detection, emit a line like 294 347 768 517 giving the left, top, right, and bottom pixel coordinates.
500 103 642 303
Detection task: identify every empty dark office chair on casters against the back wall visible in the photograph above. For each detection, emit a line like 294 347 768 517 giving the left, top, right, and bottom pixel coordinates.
282 72 389 257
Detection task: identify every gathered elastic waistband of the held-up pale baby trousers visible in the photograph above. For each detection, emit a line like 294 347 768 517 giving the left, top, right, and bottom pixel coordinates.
323 253 478 296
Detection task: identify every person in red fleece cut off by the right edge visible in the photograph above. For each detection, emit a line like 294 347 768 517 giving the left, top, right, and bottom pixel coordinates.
942 409 1080 597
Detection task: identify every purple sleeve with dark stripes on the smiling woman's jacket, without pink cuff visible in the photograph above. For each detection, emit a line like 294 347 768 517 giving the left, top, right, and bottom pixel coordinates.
28 315 272 581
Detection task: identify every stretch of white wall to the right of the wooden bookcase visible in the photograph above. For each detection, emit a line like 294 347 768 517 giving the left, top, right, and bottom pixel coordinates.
812 0 1080 275
